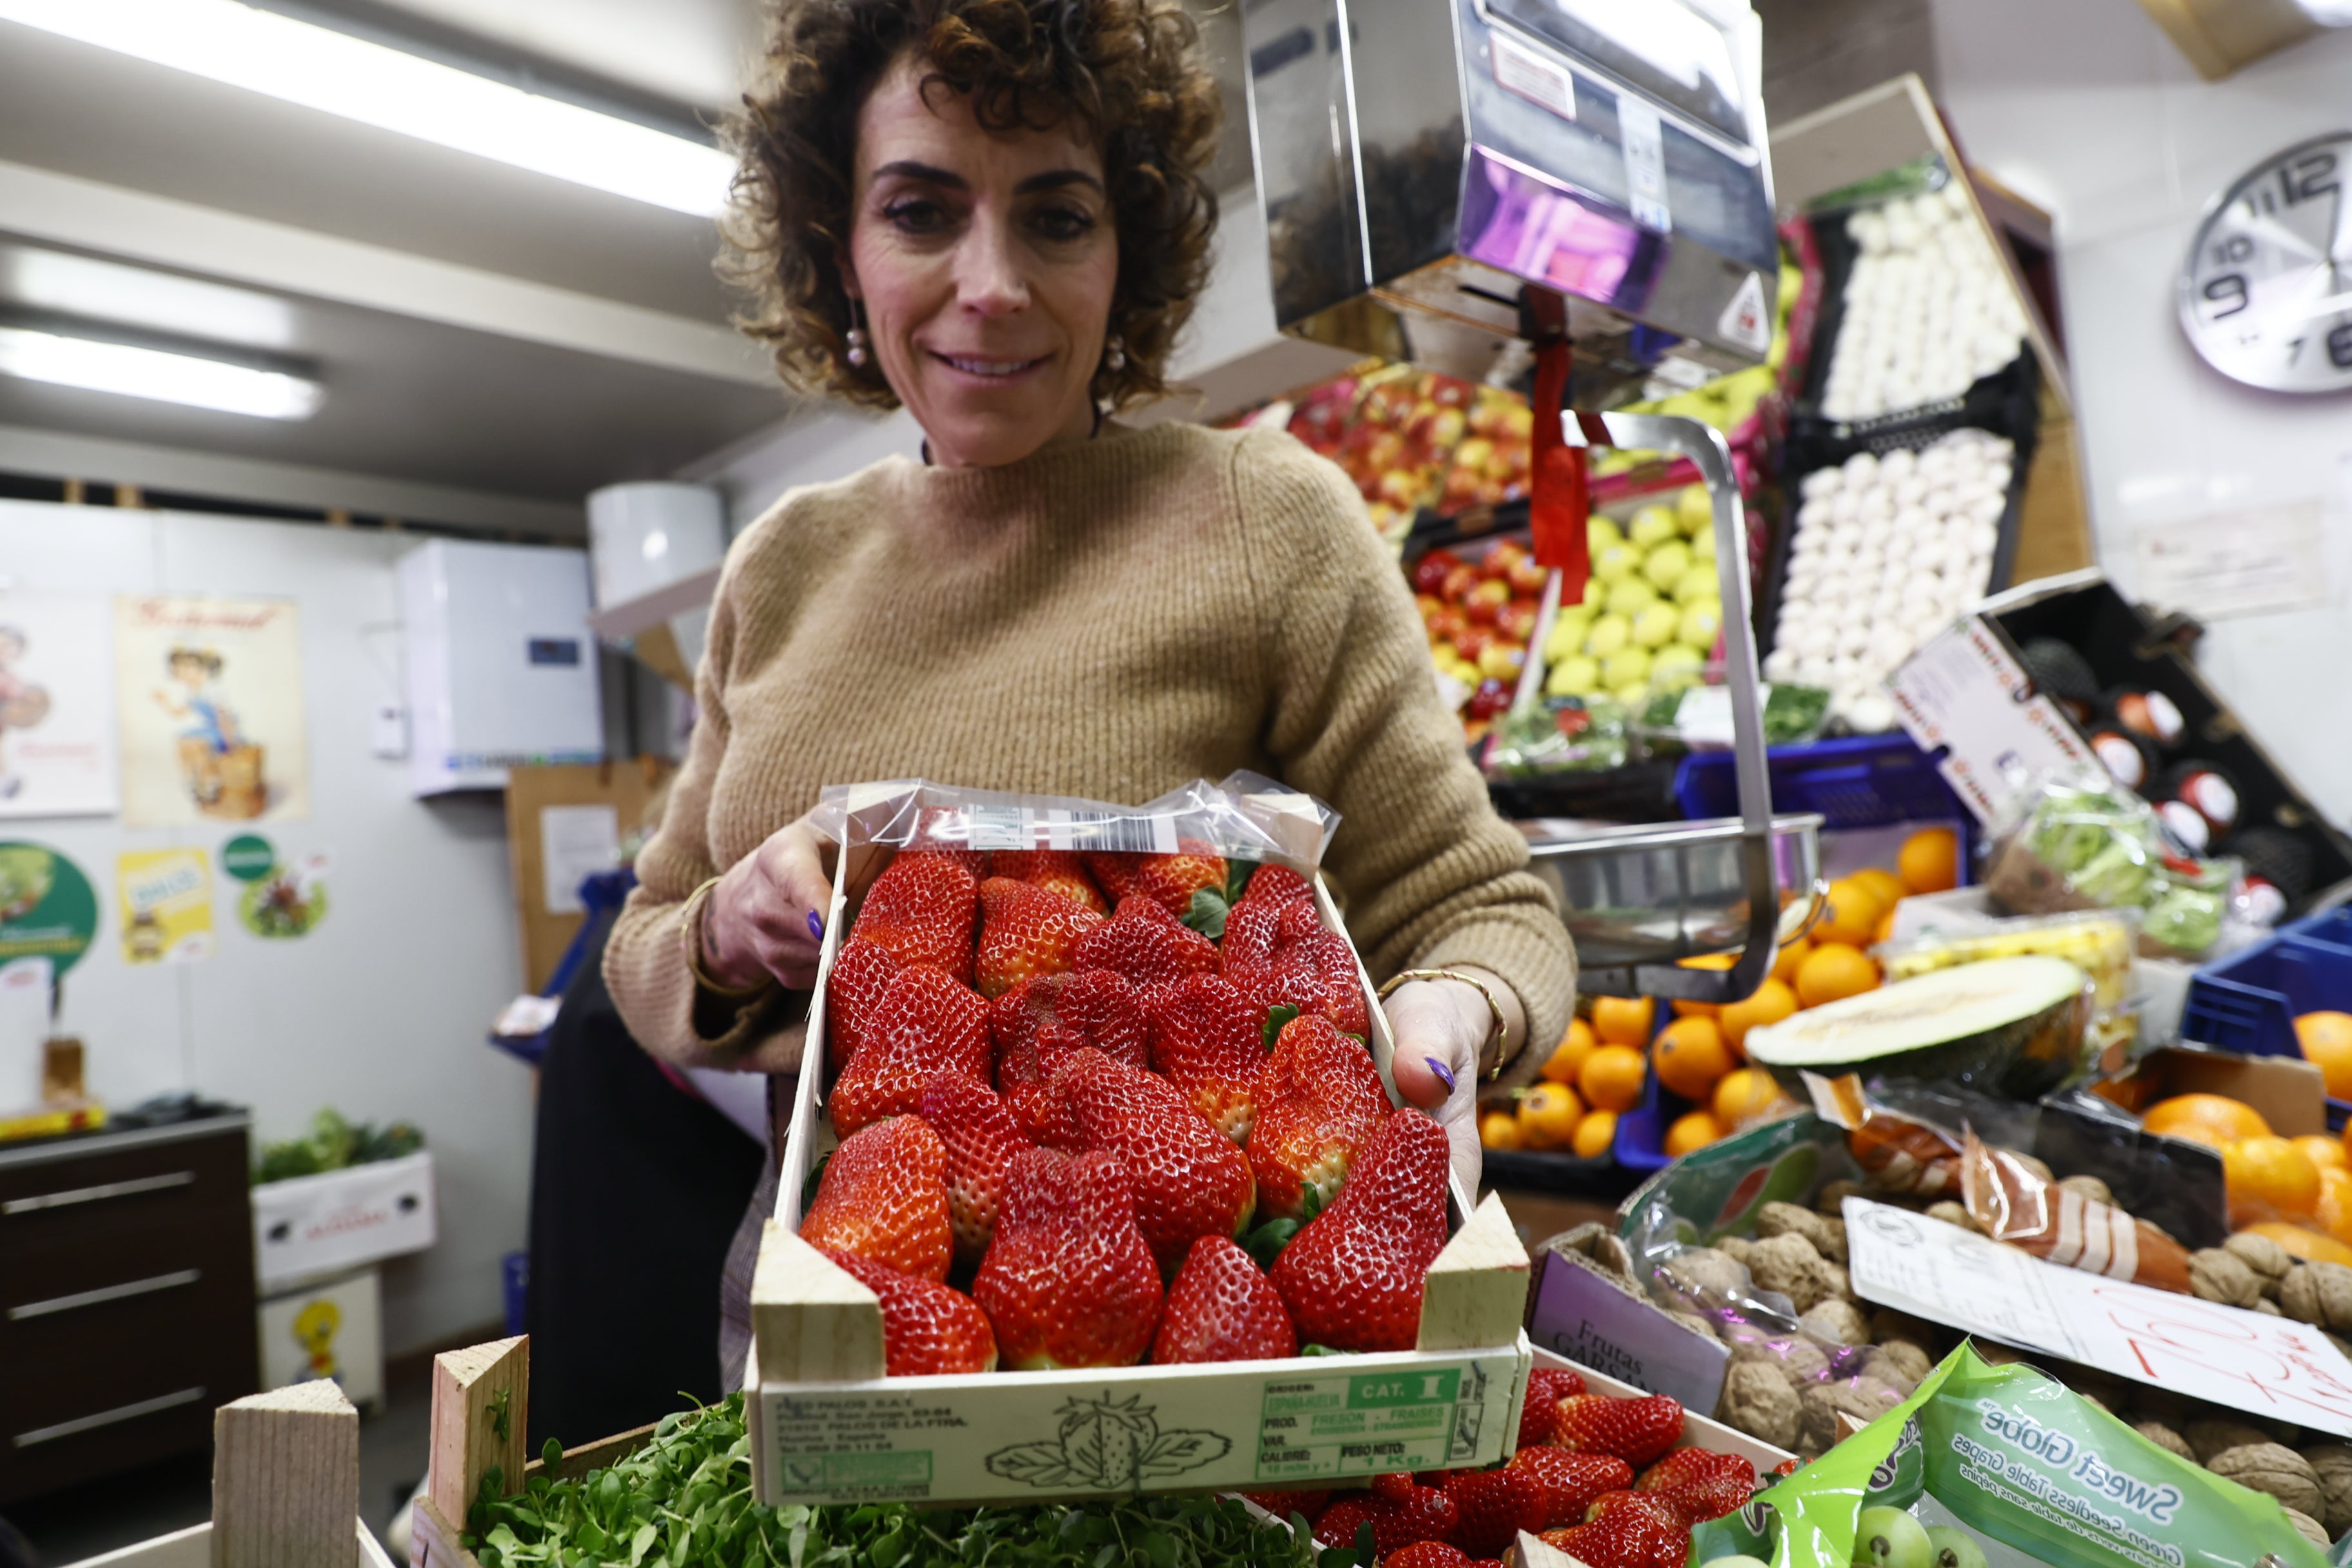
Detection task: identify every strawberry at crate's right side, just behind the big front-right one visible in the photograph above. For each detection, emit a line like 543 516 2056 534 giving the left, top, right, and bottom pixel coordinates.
1249 1015 1387 1220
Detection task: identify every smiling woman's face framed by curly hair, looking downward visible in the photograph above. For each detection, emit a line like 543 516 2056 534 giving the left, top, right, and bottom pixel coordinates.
845 59 1119 468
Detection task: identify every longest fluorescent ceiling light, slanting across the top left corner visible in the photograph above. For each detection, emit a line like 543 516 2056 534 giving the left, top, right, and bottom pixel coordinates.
0 0 734 216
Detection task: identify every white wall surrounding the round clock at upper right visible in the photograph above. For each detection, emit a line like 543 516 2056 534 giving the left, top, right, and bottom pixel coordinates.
1934 0 2352 821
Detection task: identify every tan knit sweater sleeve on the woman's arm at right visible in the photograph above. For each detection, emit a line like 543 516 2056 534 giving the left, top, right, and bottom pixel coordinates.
1235 433 1576 1067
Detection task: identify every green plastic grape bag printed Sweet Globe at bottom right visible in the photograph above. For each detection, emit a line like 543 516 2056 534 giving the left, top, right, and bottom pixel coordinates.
1691 1345 2329 1568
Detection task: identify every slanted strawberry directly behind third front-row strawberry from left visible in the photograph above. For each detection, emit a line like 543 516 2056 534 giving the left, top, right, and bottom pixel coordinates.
1054 1051 1256 1274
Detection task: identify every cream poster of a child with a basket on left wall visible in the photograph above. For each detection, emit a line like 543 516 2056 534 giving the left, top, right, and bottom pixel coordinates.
115 597 311 827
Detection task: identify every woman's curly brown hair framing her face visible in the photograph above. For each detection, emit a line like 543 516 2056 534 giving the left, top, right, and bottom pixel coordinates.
722 0 1219 409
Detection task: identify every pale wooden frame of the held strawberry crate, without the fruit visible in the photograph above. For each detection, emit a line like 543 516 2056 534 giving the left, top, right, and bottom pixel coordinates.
745 808 1533 1505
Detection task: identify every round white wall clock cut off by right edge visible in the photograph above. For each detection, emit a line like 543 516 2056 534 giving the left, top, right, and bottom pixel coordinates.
2180 130 2352 393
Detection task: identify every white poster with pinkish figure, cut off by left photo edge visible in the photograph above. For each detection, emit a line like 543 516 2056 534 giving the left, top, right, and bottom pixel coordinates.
0 594 117 816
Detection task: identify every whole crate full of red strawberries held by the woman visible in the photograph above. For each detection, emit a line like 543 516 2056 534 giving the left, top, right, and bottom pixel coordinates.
745 776 1531 1505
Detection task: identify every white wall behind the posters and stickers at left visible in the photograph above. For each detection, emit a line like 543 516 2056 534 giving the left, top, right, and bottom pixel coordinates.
0 501 531 1352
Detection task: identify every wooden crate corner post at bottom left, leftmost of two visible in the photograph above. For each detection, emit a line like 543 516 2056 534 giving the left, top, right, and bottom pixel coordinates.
211 1378 360 1568
